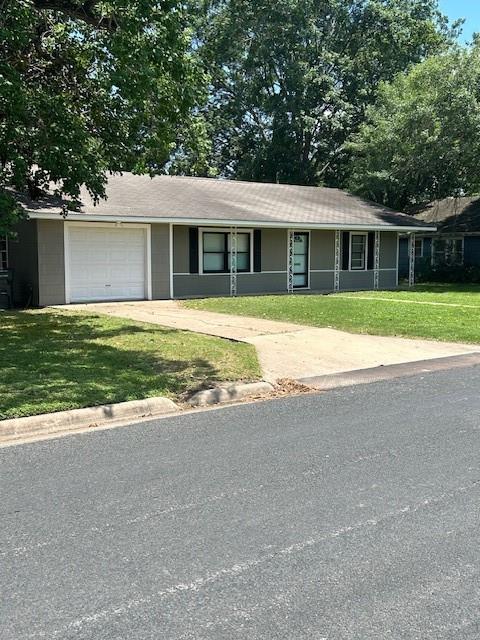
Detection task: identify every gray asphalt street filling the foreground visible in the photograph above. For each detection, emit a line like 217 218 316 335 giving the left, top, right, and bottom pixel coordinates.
0 367 480 640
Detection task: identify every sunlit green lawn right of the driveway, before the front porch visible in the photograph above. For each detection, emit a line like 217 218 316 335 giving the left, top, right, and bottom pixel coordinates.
184 285 480 343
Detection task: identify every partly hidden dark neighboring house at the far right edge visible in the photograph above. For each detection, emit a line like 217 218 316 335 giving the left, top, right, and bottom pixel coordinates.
399 197 480 277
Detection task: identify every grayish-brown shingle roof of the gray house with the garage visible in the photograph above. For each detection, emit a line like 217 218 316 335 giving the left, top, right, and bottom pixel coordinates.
24 173 432 227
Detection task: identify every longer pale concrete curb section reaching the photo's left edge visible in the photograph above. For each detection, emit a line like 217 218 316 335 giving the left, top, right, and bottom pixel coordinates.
0 397 180 441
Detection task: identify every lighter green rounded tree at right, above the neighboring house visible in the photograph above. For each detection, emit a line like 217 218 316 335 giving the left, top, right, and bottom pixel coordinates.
350 45 480 209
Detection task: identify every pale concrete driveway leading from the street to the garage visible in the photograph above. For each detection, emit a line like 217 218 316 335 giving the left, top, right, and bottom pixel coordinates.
62 300 479 381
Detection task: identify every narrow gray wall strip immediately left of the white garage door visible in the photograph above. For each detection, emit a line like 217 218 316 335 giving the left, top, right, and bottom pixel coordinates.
37 220 65 307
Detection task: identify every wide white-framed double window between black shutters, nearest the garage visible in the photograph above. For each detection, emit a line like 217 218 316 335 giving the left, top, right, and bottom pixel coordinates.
202 231 250 273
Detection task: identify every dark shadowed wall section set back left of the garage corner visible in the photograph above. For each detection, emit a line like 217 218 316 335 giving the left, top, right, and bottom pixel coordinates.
8 220 38 307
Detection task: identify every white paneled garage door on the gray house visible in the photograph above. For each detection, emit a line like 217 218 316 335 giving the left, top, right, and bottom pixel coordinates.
66 225 147 302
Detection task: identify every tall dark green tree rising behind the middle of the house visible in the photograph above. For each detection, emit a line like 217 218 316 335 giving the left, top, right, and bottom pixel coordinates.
172 0 456 185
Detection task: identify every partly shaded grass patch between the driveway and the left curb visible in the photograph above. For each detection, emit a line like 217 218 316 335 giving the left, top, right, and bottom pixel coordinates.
0 310 260 419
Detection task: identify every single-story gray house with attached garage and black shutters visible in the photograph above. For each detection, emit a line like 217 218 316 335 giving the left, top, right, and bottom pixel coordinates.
8 173 435 306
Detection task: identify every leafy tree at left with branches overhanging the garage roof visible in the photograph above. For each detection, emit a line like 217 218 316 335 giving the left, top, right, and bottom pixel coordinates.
0 0 205 235
